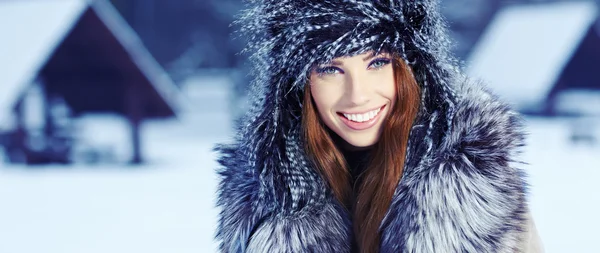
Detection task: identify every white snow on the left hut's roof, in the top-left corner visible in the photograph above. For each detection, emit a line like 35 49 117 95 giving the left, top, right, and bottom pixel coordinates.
0 0 87 126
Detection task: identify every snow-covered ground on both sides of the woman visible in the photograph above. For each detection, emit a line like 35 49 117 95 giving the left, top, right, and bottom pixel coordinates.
0 114 600 253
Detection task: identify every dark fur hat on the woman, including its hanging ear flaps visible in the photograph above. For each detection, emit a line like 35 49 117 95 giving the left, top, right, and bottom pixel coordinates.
236 0 458 211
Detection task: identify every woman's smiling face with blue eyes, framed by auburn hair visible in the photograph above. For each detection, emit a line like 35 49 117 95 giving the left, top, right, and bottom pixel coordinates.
310 52 396 148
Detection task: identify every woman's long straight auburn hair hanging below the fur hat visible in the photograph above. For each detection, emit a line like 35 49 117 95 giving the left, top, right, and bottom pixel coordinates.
302 56 420 252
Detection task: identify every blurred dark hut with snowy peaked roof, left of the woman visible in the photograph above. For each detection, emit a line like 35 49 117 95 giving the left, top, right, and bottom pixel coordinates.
0 0 179 164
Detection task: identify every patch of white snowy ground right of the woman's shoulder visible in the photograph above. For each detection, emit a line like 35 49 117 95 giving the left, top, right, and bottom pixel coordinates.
523 119 600 253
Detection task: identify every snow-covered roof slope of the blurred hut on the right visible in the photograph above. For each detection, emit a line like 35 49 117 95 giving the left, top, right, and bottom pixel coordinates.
467 1 598 109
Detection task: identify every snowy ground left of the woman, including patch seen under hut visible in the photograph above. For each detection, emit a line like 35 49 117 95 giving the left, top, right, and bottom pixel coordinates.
0 82 231 253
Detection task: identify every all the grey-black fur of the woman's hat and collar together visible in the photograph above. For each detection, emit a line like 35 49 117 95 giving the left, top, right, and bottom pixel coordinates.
216 0 526 252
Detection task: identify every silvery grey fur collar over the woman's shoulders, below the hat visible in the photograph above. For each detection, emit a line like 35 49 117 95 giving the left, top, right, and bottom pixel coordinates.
217 79 526 252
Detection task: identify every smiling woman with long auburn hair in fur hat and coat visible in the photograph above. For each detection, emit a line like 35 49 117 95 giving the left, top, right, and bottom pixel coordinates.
216 0 541 252
